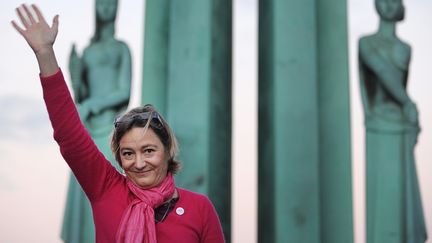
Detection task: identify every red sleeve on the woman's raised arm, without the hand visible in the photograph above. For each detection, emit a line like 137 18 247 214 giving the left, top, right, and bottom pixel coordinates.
40 69 121 201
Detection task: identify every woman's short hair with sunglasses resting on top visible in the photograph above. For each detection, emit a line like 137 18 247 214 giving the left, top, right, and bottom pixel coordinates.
111 104 180 174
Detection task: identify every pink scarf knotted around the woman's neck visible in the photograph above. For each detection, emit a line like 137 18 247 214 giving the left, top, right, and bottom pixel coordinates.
116 173 175 243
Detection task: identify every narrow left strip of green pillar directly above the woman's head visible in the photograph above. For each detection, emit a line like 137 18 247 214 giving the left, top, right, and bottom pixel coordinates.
141 0 170 114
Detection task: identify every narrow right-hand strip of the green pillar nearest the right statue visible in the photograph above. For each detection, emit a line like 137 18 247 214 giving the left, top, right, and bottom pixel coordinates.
316 0 353 243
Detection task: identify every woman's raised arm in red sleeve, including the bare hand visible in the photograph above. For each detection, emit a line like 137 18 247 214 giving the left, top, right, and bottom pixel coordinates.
12 5 121 201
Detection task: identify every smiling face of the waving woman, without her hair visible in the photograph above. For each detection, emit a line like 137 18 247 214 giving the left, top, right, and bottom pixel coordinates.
119 127 168 189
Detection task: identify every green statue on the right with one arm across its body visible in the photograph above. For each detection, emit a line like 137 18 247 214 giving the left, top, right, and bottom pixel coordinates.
359 0 427 243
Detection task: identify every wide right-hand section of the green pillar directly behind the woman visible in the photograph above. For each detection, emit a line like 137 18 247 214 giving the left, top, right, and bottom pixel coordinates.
167 0 232 241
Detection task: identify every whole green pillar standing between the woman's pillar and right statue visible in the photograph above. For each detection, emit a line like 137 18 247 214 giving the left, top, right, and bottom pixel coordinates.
258 0 353 243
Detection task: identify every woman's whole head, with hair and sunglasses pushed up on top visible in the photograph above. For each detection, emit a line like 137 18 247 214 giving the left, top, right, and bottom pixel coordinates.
111 105 180 189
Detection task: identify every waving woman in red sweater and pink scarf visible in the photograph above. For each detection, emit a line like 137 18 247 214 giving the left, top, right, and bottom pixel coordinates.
12 5 224 242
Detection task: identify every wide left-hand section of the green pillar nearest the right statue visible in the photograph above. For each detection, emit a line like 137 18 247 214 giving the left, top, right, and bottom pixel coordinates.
259 0 320 243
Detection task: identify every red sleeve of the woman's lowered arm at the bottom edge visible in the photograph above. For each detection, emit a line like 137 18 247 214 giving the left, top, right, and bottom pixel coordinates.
201 197 225 243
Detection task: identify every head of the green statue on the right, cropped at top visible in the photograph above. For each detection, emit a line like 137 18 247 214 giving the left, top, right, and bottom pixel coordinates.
375 0 405 21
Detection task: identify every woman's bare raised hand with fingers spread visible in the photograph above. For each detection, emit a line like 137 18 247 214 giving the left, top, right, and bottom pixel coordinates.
12 4 59 54
